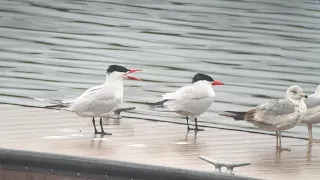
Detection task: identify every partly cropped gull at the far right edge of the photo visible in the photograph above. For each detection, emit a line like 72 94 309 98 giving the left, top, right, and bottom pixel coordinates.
301 85 320 143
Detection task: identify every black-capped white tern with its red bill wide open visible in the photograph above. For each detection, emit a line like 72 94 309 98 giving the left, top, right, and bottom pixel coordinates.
38 65 142 135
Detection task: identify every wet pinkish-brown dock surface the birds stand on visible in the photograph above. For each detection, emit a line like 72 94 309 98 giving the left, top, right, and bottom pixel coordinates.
0 104 320 179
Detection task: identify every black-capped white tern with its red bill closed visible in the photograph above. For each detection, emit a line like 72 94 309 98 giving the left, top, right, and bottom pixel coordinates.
154 73 224 131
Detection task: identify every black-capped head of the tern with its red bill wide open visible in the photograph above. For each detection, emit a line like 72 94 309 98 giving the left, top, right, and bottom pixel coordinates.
107 65 141 81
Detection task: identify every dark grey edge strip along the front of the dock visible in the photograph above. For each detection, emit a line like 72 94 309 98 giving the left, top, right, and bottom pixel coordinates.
0 148 253 180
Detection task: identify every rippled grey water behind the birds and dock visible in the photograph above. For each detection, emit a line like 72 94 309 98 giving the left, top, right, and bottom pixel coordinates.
0 0 320 137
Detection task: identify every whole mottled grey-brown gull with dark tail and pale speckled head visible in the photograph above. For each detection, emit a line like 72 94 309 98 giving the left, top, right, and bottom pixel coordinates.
220 85 308 151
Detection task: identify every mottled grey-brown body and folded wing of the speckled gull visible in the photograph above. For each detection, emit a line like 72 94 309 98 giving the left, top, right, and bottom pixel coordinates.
245 99 298 125
